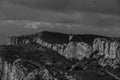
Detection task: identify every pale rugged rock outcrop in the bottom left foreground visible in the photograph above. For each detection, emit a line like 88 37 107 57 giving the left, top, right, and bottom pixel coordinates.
0 59 57 80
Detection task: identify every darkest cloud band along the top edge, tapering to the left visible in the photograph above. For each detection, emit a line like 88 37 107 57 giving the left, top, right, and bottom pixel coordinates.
5 0 120 15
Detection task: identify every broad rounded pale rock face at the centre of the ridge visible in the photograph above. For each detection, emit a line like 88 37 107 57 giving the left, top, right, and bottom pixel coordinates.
64 42 92 60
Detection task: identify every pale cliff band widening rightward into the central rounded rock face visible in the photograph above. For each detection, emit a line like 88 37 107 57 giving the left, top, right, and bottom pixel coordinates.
36 39 92 60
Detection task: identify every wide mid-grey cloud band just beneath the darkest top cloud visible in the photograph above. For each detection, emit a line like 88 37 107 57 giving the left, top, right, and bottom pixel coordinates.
0 2 120 27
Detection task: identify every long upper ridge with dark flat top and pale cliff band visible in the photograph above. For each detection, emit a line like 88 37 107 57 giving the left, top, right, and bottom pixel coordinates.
11 32 120 66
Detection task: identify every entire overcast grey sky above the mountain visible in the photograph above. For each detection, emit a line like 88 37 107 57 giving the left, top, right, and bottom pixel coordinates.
0 0 120 43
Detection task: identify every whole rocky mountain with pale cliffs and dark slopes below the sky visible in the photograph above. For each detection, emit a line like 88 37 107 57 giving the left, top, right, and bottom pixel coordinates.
0 31 120 80
